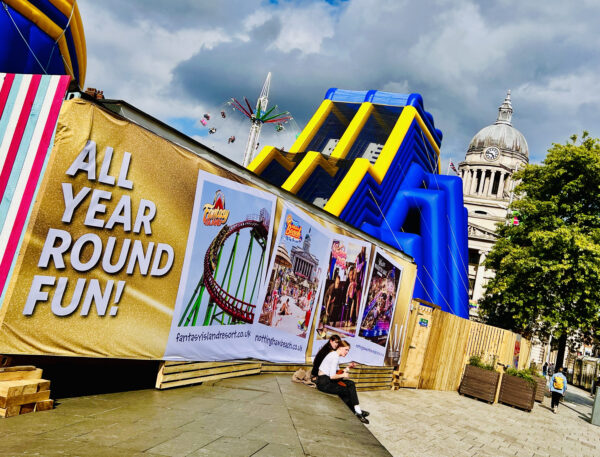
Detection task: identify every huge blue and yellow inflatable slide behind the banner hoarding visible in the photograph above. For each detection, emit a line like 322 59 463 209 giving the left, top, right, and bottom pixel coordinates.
248 88 469 318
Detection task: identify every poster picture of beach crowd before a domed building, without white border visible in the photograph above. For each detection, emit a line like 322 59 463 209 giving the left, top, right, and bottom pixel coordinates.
258 209 331 338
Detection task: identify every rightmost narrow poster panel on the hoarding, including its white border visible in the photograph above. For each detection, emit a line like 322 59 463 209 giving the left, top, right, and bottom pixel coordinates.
350 248 402 365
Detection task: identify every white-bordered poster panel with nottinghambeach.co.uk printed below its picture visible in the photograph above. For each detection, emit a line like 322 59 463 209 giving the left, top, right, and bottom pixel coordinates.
253 204 331 363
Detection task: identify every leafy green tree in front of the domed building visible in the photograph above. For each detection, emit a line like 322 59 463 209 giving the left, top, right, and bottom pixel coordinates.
480 132 600 366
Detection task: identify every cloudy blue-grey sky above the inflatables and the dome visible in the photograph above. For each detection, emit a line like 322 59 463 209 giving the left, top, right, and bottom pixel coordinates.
78 0 600 171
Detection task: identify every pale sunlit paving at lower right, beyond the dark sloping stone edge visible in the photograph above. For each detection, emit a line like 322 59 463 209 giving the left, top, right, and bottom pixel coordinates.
360 385 600 457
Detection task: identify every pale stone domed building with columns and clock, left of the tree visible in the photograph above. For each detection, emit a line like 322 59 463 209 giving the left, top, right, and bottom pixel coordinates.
458 90 529 317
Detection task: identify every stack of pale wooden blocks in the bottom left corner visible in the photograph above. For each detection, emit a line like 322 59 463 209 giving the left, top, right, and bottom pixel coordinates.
0 366 54 417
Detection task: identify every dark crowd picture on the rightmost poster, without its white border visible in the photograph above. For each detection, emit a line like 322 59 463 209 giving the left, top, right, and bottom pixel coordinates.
359 251 401 347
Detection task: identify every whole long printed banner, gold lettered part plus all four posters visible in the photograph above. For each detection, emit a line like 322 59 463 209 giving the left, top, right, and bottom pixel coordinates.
0 99 416 365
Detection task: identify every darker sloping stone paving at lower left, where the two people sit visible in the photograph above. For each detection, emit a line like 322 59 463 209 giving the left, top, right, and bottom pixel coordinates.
0 375 390 457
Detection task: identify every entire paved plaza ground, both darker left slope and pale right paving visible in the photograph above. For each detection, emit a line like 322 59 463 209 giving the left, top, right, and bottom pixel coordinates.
0 375 600 457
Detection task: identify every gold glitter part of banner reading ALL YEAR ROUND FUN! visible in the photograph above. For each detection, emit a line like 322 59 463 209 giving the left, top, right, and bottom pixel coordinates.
0 99 416 359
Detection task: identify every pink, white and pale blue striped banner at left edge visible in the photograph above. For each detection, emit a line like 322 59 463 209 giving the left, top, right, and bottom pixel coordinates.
0 73 70 296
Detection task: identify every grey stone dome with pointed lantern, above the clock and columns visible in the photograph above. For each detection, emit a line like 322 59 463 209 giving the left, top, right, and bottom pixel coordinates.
467 90 529 161
